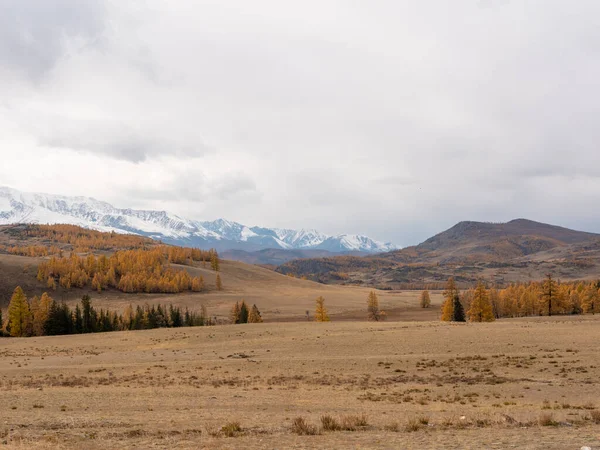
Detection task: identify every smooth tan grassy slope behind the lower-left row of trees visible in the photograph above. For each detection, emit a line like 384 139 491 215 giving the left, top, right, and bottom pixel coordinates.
0 255 442 322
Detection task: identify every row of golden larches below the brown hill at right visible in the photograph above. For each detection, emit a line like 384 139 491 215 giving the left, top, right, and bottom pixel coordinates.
441 274 600 322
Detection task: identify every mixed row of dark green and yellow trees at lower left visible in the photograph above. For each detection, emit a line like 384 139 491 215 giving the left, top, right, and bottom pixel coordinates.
0 287 213 337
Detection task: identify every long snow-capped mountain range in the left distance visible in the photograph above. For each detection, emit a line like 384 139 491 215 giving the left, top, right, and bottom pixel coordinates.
0 187 397 253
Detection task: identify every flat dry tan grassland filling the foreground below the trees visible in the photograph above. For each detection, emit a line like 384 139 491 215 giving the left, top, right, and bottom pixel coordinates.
0 314 600 449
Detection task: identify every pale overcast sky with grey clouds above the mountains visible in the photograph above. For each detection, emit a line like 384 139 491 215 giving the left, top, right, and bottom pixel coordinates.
0 0 600 246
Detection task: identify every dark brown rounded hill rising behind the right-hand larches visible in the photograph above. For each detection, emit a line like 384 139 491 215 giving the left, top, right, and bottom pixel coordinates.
277 219 600 288
